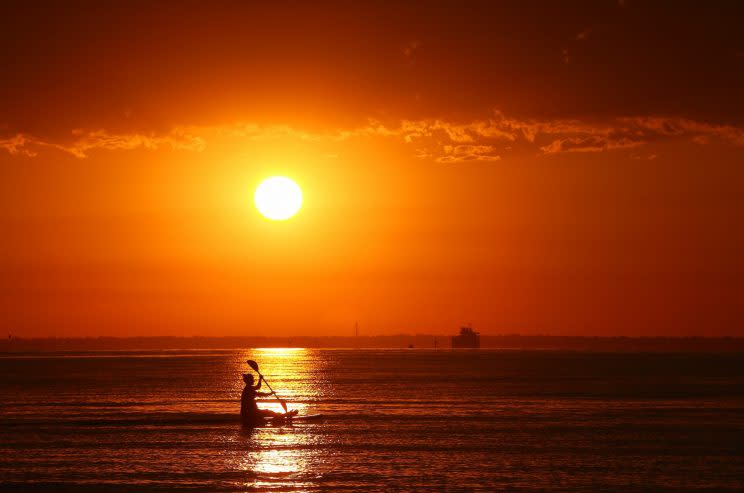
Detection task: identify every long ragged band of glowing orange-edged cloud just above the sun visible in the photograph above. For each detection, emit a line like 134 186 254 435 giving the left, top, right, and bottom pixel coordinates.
0 111 744 163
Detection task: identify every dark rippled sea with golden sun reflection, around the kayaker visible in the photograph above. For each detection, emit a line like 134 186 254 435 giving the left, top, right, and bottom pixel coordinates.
0 349 744 492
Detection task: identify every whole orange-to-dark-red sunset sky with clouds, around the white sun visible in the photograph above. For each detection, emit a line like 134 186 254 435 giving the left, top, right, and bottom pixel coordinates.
0 0 744 337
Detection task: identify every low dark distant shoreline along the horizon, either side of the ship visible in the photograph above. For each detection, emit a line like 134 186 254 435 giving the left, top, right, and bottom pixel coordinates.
0 334 744 353
